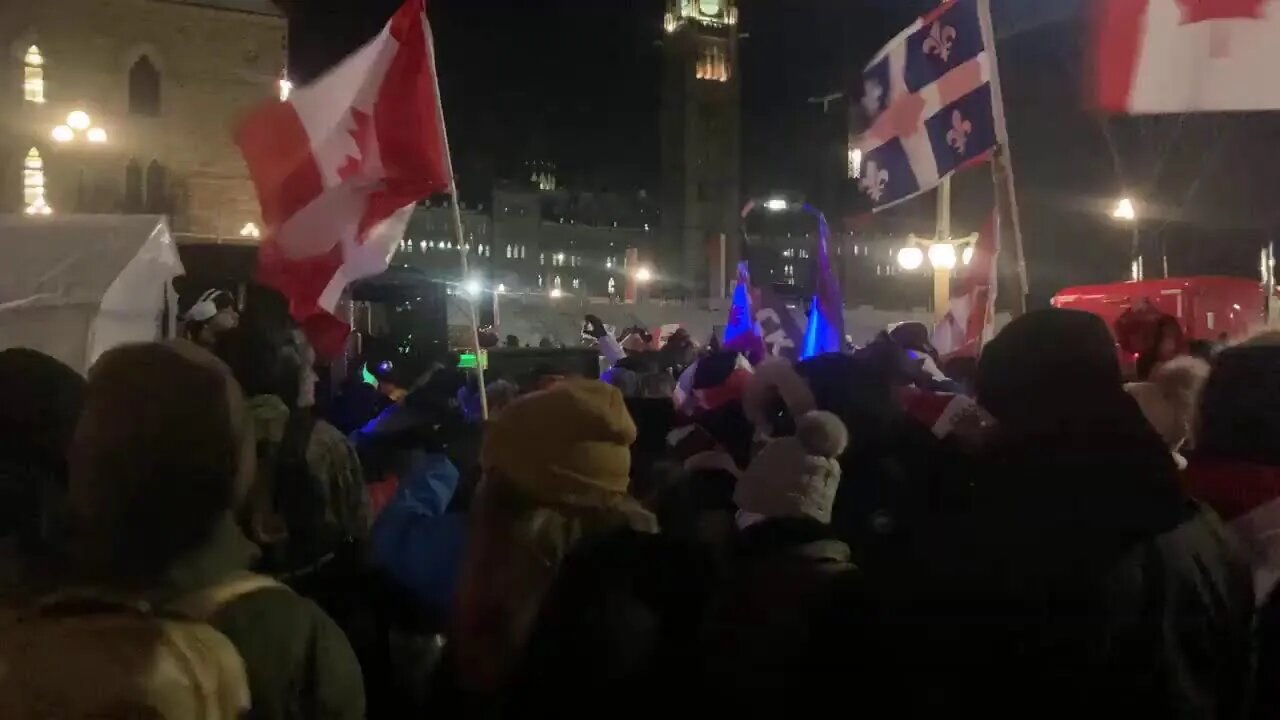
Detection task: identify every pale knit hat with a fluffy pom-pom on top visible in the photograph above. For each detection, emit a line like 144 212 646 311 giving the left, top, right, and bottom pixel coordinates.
733 410 849 523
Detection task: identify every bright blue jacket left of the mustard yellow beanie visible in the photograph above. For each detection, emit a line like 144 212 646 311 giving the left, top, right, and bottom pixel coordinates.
372 450 467 614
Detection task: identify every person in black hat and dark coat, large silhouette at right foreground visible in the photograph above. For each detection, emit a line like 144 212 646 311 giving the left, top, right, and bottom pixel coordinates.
908 310 1253 719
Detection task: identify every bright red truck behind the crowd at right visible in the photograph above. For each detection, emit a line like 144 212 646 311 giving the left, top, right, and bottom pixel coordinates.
1053 277 1267 342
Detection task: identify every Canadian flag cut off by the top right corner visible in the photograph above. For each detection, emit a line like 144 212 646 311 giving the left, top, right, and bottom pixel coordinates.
1096 0 1280 114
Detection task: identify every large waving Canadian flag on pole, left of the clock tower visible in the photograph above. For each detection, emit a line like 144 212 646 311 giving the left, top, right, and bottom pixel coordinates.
237 0 451 356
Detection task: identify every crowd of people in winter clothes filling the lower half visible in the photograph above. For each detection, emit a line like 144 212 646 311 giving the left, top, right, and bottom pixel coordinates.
0 286 1280 719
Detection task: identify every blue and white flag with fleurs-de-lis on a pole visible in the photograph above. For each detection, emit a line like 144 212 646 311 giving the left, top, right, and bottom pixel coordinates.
859 0 997 210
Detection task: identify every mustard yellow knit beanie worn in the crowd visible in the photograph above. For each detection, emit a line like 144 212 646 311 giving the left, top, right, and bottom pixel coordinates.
480 380 636 502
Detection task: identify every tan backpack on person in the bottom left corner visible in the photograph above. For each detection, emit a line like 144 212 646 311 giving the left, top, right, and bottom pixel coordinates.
0 573 279 720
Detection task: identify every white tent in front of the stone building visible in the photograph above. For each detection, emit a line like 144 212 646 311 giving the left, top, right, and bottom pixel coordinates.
0 215 183 373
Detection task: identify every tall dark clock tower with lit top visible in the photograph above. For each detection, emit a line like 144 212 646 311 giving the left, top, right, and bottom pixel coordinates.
659 0 742 299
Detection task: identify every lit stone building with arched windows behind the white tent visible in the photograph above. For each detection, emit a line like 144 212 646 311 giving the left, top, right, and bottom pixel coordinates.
0 0 285 240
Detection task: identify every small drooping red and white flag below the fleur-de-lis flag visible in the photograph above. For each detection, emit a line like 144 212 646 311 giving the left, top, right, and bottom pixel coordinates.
933 213 1000 357
